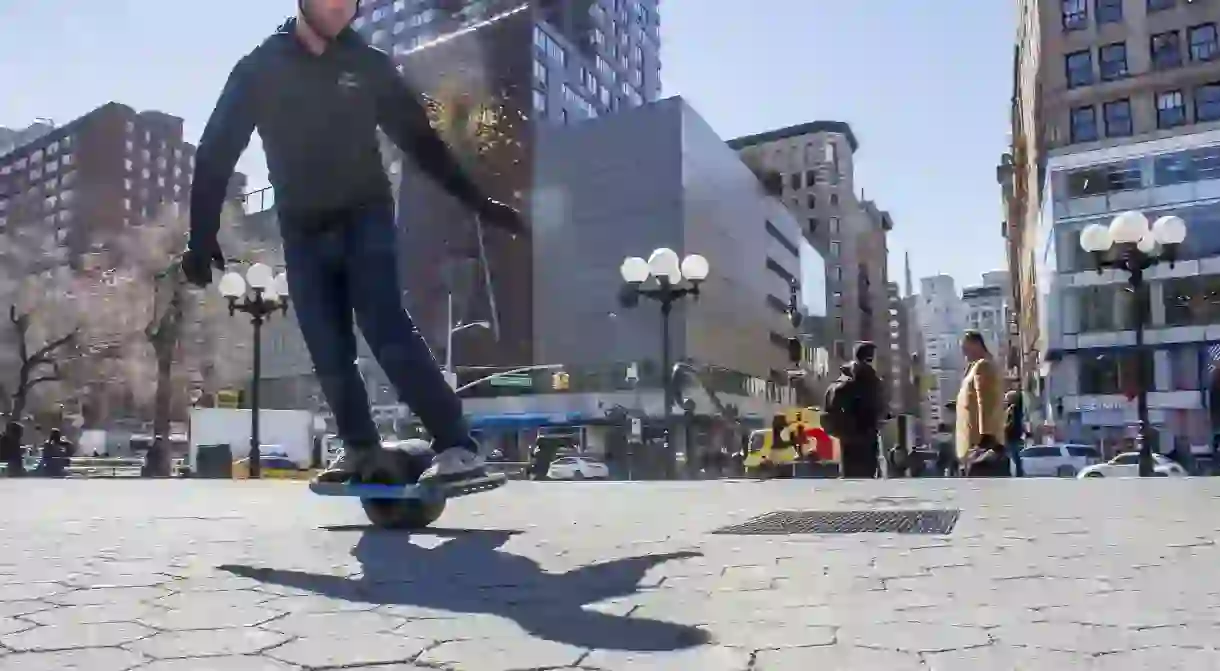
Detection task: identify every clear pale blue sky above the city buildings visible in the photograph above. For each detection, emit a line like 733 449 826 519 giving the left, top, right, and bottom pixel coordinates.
0 0 1014 291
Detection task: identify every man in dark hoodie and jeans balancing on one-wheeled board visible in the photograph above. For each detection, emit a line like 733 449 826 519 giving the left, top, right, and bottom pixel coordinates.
182 0 523 492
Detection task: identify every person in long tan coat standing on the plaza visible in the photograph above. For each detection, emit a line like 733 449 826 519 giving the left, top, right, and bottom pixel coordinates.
954 331 1013 477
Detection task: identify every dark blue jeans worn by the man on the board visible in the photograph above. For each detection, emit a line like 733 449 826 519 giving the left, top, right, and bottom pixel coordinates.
281 204 477 451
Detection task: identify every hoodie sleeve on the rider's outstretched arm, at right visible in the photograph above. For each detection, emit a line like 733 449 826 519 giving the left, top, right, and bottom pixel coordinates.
373 49 487 207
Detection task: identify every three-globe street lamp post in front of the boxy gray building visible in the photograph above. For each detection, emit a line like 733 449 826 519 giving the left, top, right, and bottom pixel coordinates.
619 248 709 478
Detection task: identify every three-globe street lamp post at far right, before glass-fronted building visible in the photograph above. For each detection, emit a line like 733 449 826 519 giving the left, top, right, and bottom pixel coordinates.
1080 211 1186 477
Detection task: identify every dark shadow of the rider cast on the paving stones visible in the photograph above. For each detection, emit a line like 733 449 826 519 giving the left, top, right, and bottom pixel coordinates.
220 529 710 651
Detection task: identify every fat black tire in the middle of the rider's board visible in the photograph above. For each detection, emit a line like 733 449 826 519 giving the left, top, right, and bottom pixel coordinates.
360 440 445 529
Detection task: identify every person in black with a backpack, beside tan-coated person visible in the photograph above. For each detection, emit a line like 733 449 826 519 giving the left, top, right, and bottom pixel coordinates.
822 342 886 478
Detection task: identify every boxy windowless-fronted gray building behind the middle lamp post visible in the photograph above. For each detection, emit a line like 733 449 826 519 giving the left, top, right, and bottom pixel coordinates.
533 98 800 400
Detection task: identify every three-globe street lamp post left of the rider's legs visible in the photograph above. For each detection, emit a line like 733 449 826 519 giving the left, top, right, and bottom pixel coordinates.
220 264 288 479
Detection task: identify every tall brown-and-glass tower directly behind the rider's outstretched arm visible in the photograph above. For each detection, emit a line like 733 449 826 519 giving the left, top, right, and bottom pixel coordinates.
354 0 661 366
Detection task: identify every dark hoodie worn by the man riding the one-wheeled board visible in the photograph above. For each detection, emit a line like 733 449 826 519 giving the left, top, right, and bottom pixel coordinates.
190 18 487 249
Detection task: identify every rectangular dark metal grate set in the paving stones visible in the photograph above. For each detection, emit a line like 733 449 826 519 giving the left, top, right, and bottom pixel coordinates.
711 510 961 536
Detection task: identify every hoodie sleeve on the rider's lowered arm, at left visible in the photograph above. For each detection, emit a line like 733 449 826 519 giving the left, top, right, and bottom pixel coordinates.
190 55 255 249
